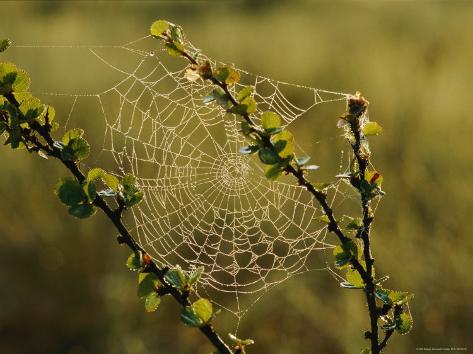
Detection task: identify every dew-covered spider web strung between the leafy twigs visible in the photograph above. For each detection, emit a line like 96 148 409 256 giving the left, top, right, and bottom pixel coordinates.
16 36 349 319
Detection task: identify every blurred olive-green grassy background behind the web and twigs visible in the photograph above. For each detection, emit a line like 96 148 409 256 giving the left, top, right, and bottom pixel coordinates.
0 0 473 354
